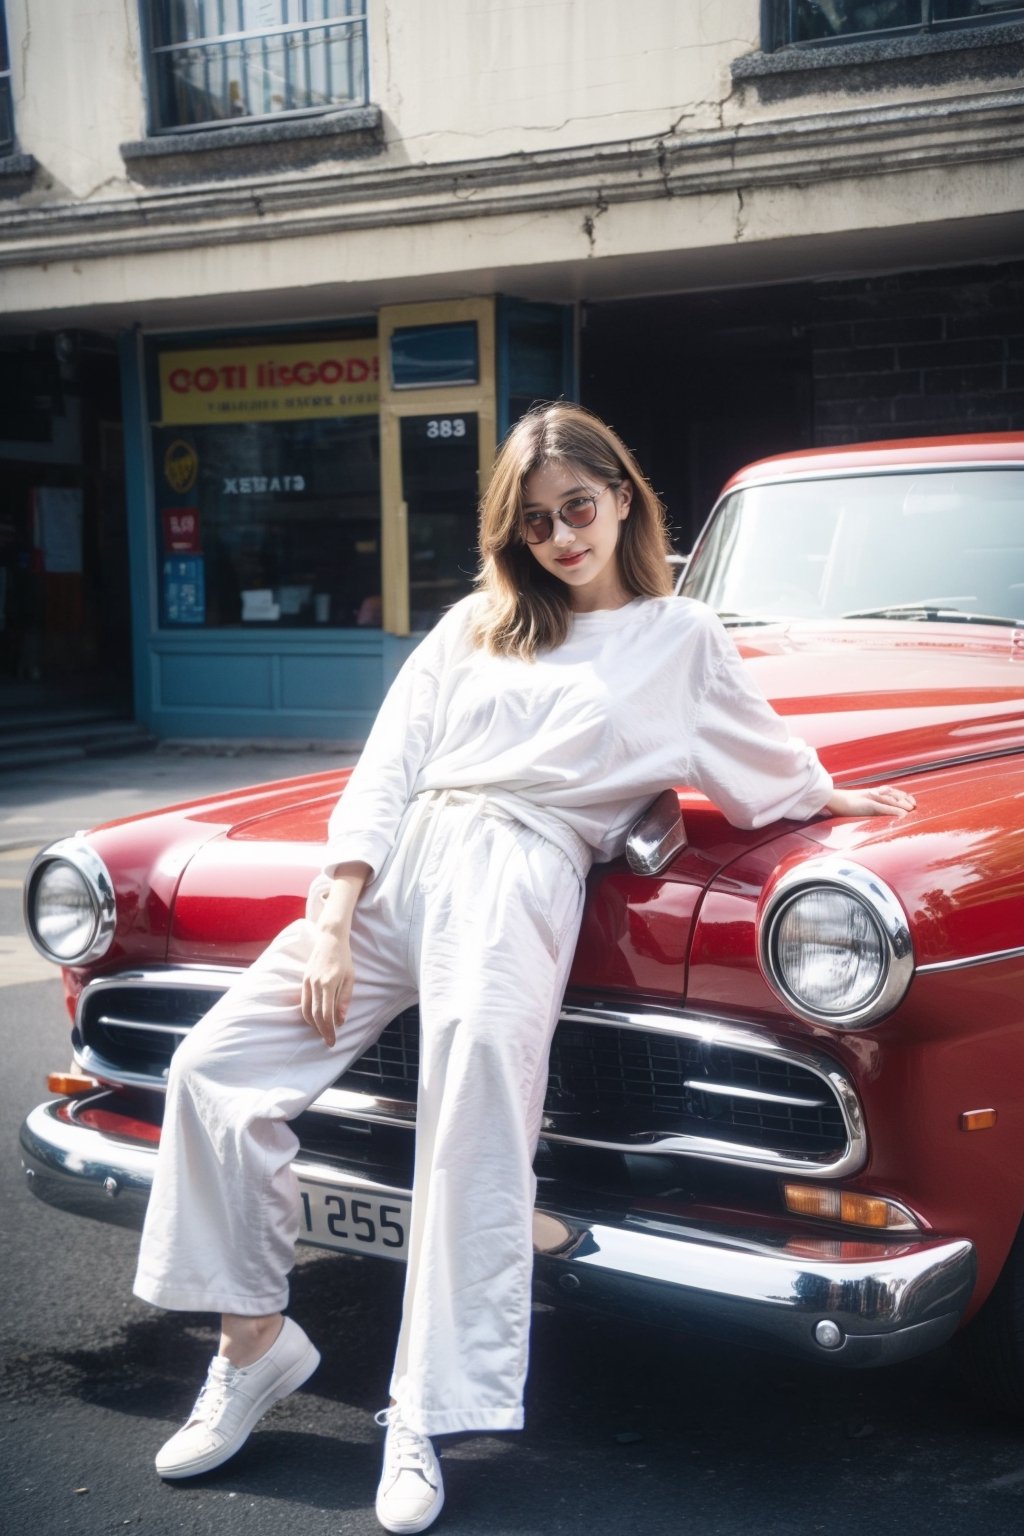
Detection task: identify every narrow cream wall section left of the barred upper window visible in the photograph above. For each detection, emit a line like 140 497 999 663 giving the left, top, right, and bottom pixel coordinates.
6 0 144 201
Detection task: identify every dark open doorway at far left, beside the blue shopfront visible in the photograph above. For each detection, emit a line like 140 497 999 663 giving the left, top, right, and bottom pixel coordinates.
0 330 130 709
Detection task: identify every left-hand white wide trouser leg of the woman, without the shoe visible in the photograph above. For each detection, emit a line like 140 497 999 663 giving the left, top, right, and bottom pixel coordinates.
135 903 415 1320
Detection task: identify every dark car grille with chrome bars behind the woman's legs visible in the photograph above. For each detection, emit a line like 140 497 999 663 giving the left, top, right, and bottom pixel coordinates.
75 969 858 1169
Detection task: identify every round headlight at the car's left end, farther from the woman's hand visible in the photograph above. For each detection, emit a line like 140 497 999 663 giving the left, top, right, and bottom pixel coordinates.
25 837 115 965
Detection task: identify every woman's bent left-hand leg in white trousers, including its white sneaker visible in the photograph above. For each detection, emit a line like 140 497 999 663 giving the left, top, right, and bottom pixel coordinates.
135 899 415 1478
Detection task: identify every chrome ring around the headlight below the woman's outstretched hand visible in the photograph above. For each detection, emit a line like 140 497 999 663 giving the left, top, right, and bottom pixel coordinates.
758 854 913 1029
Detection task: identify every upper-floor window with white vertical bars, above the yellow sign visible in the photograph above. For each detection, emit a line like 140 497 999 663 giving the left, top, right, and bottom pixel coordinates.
143 0 367 134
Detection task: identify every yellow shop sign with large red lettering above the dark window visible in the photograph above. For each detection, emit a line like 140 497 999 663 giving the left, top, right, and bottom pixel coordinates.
160 336 379 427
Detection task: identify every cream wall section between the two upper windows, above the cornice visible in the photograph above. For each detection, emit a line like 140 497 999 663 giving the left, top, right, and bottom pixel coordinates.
370 0 760 164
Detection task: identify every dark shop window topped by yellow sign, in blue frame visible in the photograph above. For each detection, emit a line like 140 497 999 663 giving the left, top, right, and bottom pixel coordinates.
149 333 381 630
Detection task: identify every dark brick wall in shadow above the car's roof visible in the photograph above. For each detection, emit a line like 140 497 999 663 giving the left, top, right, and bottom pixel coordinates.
809 261 1024 447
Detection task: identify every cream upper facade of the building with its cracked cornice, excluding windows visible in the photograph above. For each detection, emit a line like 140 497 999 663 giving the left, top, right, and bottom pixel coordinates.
0 0 1024 324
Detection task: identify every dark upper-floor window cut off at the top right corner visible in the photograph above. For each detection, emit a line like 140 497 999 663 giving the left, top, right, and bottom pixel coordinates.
765 0 1024 48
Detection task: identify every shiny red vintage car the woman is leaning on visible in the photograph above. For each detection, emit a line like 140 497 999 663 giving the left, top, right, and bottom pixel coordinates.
14 435 1024 1410
